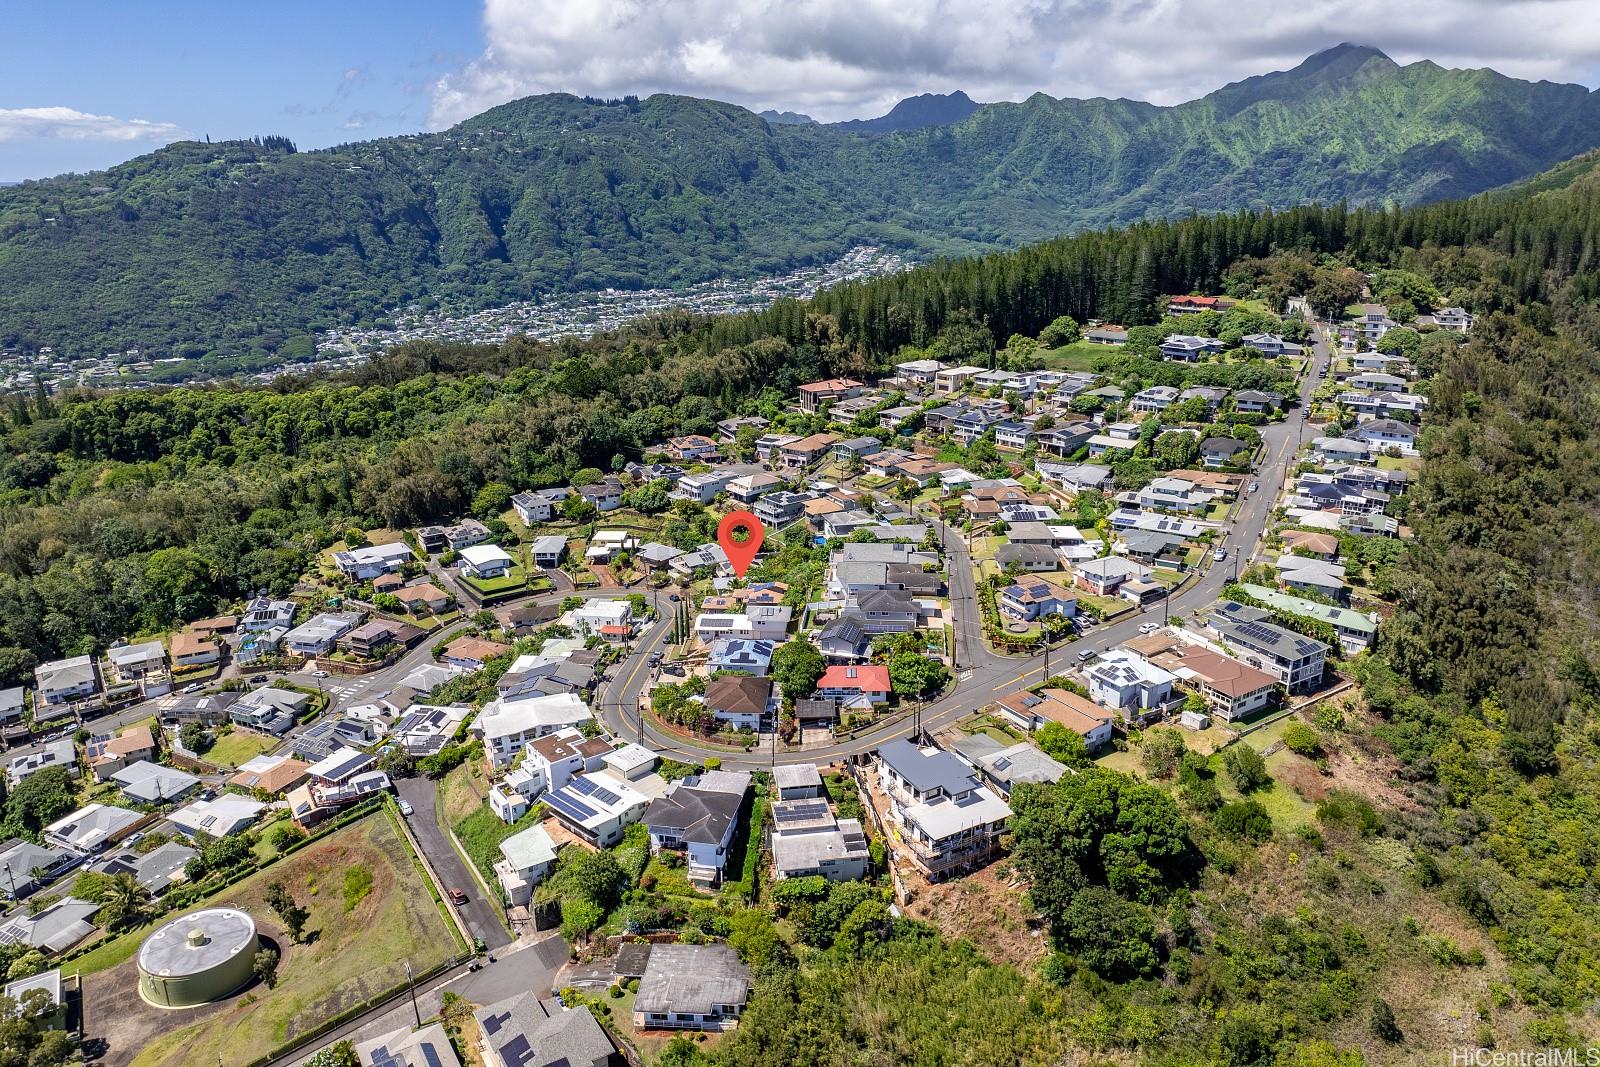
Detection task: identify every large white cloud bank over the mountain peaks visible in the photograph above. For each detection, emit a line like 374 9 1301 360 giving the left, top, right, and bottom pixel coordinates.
430 0 1600 126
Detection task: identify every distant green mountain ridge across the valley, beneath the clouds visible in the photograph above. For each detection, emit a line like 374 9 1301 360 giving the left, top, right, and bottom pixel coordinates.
0 45 1600 358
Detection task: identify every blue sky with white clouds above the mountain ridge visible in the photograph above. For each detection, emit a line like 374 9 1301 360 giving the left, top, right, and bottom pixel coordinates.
9 0 1600 182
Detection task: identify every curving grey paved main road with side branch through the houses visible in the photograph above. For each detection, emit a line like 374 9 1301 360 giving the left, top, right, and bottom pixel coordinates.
600 330 1328 769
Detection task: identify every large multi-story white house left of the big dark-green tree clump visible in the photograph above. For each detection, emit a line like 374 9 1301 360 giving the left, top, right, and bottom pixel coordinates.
877 741 1011 881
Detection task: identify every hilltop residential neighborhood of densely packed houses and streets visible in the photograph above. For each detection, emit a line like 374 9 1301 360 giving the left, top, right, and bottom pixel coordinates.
0 279 1440 1065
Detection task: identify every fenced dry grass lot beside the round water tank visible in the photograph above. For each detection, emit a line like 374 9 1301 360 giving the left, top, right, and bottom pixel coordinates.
120 813 459 1067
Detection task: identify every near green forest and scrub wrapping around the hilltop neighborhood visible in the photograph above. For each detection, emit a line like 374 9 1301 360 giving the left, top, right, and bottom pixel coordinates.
0 146 1600 1067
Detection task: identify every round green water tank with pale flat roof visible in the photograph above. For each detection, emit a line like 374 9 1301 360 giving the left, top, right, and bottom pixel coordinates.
139 907 259 1008
